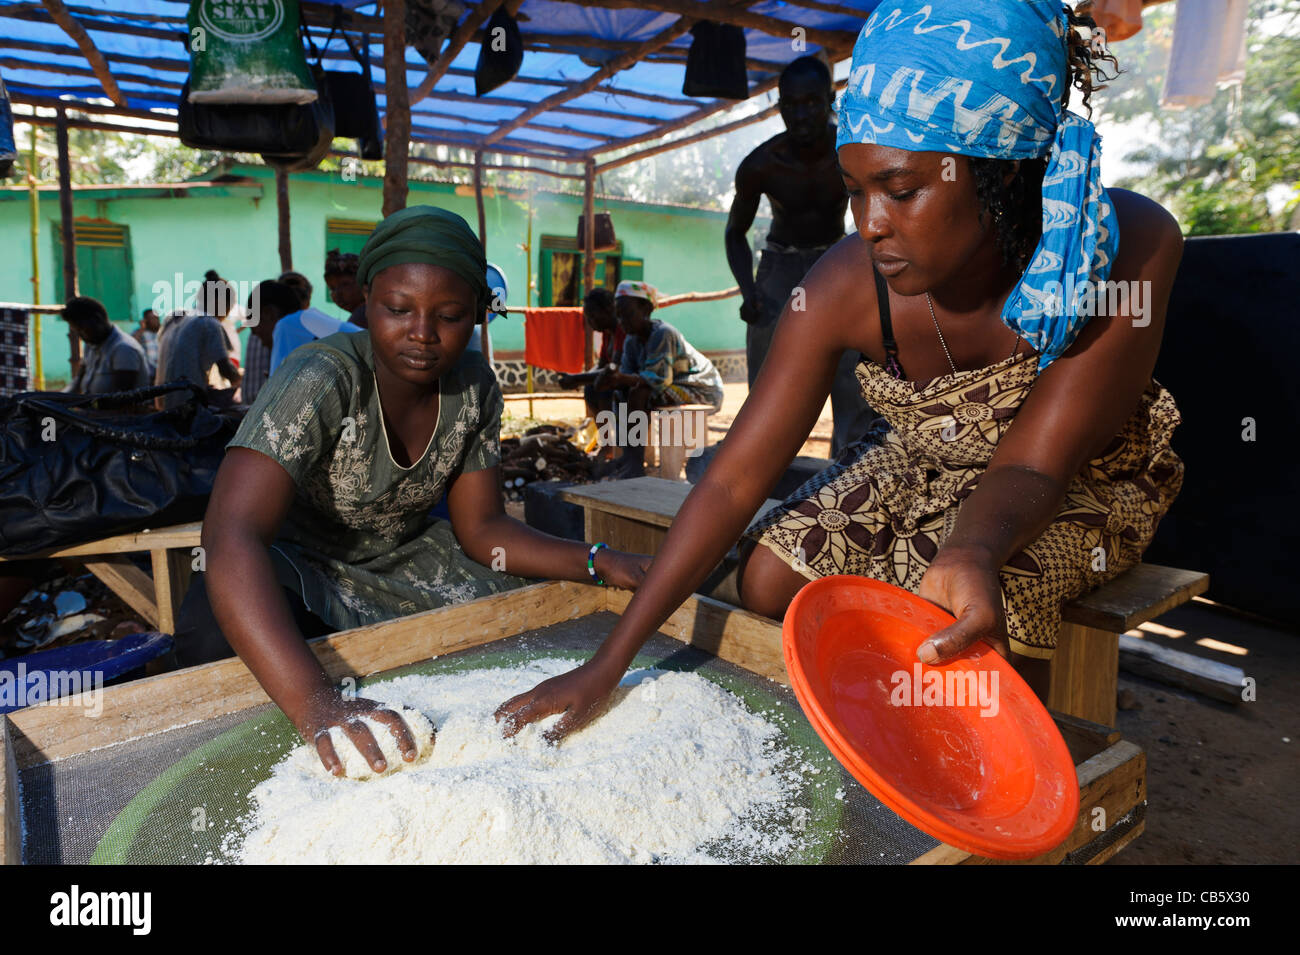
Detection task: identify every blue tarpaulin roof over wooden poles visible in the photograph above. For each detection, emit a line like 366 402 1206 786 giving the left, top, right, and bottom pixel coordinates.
0 0 879 161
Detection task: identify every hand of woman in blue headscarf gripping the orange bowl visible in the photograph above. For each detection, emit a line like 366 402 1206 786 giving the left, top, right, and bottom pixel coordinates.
917 548 1011 663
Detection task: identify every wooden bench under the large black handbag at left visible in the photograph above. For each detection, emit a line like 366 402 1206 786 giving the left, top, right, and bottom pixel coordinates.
0 521 203 634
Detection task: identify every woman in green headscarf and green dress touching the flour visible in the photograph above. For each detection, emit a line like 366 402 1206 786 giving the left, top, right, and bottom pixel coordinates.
177 207 644 772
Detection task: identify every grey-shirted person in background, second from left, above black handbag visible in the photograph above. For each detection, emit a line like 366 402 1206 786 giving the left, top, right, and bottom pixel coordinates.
153 281 242 409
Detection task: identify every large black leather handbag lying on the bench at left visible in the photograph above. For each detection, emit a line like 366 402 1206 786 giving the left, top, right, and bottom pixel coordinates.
0 382 238 557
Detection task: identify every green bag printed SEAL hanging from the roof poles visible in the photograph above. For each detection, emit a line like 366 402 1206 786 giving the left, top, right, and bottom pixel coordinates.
189 0 317 104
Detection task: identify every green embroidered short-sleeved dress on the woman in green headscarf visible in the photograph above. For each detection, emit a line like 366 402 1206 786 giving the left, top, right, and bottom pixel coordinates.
230 333 527 630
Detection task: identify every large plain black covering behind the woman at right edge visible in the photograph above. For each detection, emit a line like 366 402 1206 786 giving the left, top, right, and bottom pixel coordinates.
1144 233 1300 624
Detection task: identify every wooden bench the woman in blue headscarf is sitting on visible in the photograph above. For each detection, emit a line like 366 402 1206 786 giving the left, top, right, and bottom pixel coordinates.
560 477 1209 726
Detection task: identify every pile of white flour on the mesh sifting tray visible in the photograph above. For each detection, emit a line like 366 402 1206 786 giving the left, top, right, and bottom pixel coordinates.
226 659 811 864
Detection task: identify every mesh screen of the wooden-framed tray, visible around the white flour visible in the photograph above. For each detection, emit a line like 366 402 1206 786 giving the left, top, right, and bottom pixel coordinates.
20 613 939 865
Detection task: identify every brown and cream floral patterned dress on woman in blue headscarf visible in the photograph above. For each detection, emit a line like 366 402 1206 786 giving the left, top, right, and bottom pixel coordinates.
746 353 1183 657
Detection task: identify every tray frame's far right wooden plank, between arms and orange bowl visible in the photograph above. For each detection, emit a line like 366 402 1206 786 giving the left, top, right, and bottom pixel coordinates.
606 590 790 686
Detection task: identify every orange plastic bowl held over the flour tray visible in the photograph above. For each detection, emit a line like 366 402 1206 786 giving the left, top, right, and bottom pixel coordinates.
781 576 1079 859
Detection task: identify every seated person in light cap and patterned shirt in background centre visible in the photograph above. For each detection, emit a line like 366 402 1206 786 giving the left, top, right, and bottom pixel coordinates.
595 282 724 478
